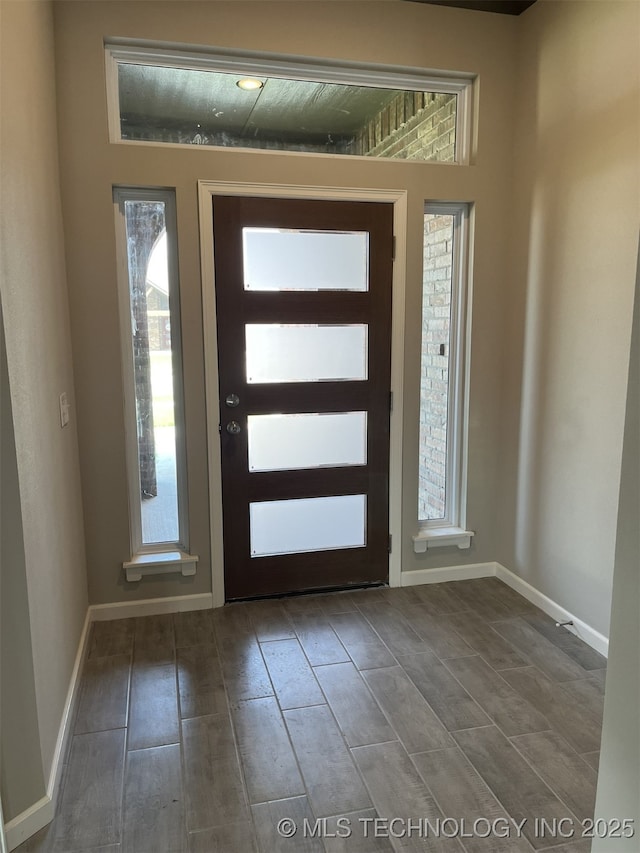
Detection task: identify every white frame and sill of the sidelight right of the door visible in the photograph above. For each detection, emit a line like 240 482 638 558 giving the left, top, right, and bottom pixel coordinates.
413 201 474 553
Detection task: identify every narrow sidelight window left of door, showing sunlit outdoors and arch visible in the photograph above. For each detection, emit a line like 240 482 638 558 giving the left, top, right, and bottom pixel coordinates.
114 189 188 562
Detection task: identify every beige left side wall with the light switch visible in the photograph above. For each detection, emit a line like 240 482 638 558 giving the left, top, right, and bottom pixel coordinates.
0 0 87 781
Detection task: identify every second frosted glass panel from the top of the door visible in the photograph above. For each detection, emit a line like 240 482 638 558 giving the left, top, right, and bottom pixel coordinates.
245 324 368 383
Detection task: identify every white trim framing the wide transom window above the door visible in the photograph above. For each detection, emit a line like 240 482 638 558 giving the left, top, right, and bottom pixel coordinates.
104 38 477 166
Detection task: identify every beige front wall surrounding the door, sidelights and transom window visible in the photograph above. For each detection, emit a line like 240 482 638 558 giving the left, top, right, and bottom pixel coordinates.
55 0 516 603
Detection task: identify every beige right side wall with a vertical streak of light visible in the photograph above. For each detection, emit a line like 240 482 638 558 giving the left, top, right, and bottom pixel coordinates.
497 0 640 635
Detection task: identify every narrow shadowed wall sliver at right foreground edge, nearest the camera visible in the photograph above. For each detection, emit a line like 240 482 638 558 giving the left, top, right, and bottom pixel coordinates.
592 243 640 853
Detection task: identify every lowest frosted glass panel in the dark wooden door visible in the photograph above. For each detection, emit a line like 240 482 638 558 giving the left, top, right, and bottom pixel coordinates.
249 495 367 557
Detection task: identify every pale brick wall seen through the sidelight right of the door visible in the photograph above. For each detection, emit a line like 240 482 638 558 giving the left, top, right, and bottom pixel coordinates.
418 214 453 520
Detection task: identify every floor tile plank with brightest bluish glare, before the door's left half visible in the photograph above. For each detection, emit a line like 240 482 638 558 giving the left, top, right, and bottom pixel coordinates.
262 640 325 710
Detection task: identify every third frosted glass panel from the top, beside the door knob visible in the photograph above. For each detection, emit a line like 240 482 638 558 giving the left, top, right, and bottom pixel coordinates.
248 412 367 471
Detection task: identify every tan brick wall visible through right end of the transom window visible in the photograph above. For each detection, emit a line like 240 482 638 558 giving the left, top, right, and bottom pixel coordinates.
353 92 456 162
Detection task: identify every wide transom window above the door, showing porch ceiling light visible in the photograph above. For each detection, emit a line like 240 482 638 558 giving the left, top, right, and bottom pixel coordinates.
107 45 471 163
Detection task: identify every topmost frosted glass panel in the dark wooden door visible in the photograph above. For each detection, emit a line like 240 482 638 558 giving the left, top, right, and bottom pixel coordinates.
242 228 369 291
